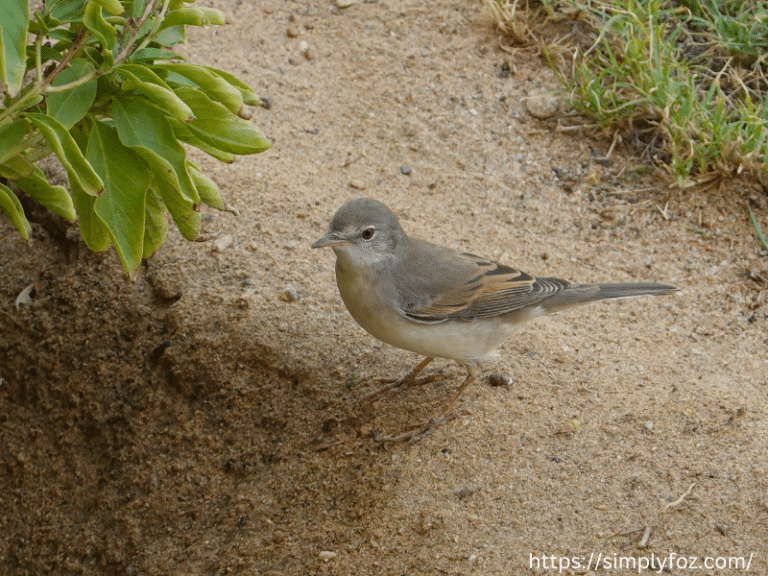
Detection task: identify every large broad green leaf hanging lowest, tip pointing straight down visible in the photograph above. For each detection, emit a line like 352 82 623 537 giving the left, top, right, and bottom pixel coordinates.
85 120 149 275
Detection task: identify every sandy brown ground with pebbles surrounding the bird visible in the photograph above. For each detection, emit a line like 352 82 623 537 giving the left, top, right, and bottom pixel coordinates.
0 0 768 576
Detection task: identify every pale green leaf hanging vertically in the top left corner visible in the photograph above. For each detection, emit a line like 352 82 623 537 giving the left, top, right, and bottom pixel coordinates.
0 0 29 94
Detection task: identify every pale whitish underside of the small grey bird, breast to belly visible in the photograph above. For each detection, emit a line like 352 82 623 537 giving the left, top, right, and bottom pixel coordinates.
336 268 515 360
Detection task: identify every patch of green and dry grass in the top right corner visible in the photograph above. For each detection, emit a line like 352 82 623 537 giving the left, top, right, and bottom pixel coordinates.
486 0 768 187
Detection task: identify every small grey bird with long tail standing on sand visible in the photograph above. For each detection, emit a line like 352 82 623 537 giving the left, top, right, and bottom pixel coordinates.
312 198 679 443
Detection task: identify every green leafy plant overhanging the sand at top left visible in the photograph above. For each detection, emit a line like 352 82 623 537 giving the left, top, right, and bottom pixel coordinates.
0 0 270 274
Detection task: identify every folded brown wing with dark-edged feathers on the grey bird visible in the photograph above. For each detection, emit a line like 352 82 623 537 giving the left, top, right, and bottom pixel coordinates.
400 246 571 323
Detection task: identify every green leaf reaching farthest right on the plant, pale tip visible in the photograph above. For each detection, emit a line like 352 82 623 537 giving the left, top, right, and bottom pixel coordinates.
173 84 271 154
